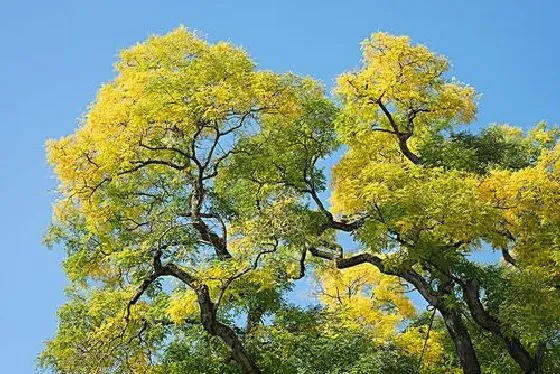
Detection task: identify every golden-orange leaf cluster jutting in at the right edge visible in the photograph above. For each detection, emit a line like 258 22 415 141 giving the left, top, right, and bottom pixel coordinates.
479 146 560 279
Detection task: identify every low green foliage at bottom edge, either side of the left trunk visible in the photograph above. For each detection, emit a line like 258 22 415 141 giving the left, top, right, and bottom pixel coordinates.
155 306 417 374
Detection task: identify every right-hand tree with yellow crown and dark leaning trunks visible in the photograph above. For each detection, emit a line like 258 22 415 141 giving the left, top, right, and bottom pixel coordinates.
328 35 560 372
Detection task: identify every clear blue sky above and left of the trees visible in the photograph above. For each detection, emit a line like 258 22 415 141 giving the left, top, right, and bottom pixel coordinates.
0 0 560 374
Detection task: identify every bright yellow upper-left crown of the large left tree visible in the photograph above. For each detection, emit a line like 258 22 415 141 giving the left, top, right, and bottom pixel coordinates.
47 28 310 240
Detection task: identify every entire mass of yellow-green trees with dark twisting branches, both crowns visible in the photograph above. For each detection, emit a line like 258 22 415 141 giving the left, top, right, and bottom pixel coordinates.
40 28 560 373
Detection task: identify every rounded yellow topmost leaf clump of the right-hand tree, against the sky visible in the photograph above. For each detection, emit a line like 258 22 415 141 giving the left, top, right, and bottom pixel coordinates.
335 33 477 152
